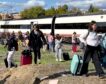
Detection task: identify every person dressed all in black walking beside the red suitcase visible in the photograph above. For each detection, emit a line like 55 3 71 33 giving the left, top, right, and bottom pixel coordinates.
28 25 47 64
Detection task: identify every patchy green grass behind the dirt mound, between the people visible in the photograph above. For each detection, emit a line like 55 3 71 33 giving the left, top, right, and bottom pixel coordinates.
0 44 94 70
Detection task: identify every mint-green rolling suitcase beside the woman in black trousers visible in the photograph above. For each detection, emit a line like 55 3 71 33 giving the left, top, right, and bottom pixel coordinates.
70 54 83 75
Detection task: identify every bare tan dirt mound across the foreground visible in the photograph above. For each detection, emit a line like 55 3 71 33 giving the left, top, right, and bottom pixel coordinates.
0 65 106 84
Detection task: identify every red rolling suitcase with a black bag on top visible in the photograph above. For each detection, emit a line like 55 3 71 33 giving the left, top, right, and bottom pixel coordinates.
20 50 32 65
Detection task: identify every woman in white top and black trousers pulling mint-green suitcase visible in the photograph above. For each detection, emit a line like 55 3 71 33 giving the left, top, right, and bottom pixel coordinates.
79 21 105 78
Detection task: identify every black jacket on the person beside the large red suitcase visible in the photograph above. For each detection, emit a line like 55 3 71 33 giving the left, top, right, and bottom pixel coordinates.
28 30 46 49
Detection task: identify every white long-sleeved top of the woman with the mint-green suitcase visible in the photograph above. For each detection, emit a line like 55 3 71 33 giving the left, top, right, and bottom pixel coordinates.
79 32 100 47
